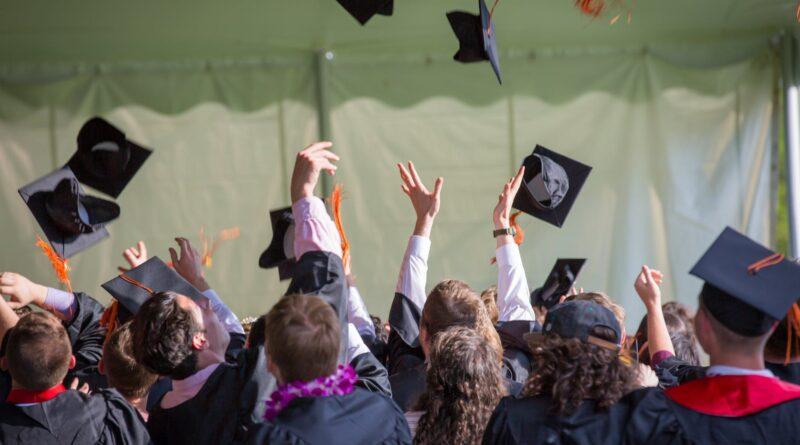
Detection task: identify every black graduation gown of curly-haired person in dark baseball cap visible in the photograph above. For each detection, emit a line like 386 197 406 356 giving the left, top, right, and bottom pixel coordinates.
483 396 625 444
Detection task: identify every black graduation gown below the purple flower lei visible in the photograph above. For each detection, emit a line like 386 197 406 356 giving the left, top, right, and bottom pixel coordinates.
249 388 411 445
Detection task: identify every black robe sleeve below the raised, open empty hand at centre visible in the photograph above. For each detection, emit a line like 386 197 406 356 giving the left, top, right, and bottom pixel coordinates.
386 293 425 375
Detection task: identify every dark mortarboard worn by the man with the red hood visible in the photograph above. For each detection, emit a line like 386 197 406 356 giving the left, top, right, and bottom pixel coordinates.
690 227 800 337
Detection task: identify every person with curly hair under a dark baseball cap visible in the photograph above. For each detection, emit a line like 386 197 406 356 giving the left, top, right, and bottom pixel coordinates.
483 300 637 444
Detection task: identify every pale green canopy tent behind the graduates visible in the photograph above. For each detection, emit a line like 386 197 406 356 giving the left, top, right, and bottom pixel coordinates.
0 0 800 327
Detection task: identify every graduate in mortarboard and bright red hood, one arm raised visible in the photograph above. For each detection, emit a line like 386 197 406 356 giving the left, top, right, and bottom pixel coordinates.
621 228 800 444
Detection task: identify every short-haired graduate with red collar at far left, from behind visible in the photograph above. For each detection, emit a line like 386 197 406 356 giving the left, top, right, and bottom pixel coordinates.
0 310 150 444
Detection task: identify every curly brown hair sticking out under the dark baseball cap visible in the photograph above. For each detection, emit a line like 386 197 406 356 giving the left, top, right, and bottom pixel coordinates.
523 327 636 415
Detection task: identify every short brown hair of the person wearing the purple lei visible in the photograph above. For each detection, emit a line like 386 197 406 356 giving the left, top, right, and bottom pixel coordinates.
264 295 341 383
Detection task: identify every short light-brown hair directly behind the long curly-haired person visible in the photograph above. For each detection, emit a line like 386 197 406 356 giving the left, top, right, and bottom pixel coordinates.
419 280 503 360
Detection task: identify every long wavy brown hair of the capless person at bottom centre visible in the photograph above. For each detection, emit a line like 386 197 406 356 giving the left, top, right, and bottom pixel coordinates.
414 326 506 444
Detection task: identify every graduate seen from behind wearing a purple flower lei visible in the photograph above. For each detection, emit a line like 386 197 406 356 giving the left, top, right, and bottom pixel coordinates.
250 295 411 444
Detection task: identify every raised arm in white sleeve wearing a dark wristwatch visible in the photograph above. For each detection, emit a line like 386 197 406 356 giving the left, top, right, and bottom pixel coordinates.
492 167 536 322
